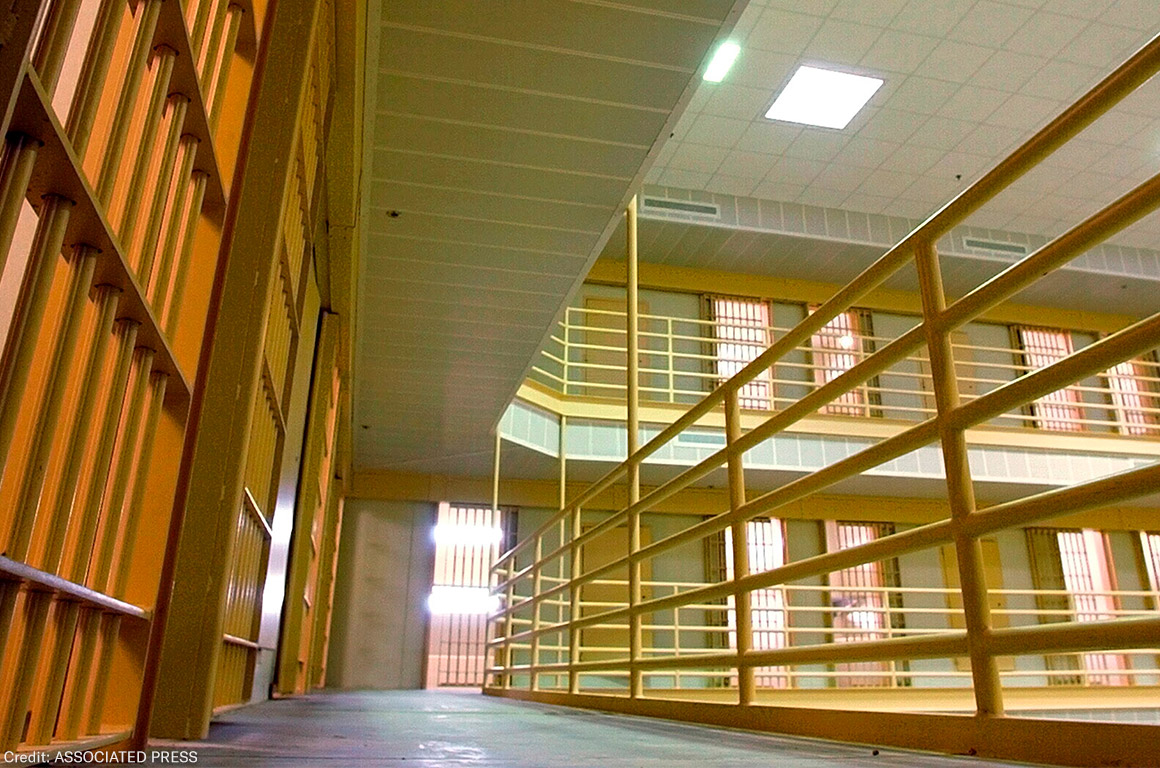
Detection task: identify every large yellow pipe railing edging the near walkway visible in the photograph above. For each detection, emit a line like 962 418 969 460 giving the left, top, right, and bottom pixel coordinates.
487 25 1160 765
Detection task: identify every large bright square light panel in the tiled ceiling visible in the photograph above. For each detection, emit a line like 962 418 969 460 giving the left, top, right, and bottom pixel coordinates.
766 66 883 129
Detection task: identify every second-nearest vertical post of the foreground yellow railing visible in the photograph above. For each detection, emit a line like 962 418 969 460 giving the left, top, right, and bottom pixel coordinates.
725 389 757 707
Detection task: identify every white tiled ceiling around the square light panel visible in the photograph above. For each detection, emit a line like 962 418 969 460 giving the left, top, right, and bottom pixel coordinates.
646 0 1160 248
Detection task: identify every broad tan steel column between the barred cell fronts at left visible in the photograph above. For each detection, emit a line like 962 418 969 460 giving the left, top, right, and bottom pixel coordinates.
147 0 319 738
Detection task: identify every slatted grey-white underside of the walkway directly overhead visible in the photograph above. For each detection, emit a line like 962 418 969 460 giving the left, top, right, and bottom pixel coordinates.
353 0 745 473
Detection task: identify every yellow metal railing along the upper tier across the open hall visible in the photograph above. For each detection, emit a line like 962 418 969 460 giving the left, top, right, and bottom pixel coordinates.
531 306 1160 437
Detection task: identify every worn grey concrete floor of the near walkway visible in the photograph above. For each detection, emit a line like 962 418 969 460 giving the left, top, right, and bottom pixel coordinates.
155 691 1034 768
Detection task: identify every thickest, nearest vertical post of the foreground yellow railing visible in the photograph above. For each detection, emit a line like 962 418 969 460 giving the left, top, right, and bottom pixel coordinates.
914 242 1003 716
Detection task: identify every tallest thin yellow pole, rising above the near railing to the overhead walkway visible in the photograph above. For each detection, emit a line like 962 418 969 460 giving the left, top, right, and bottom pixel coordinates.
624 195 644 698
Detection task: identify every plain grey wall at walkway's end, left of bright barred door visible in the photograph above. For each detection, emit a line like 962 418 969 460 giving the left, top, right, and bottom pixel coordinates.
327 499 437 689
